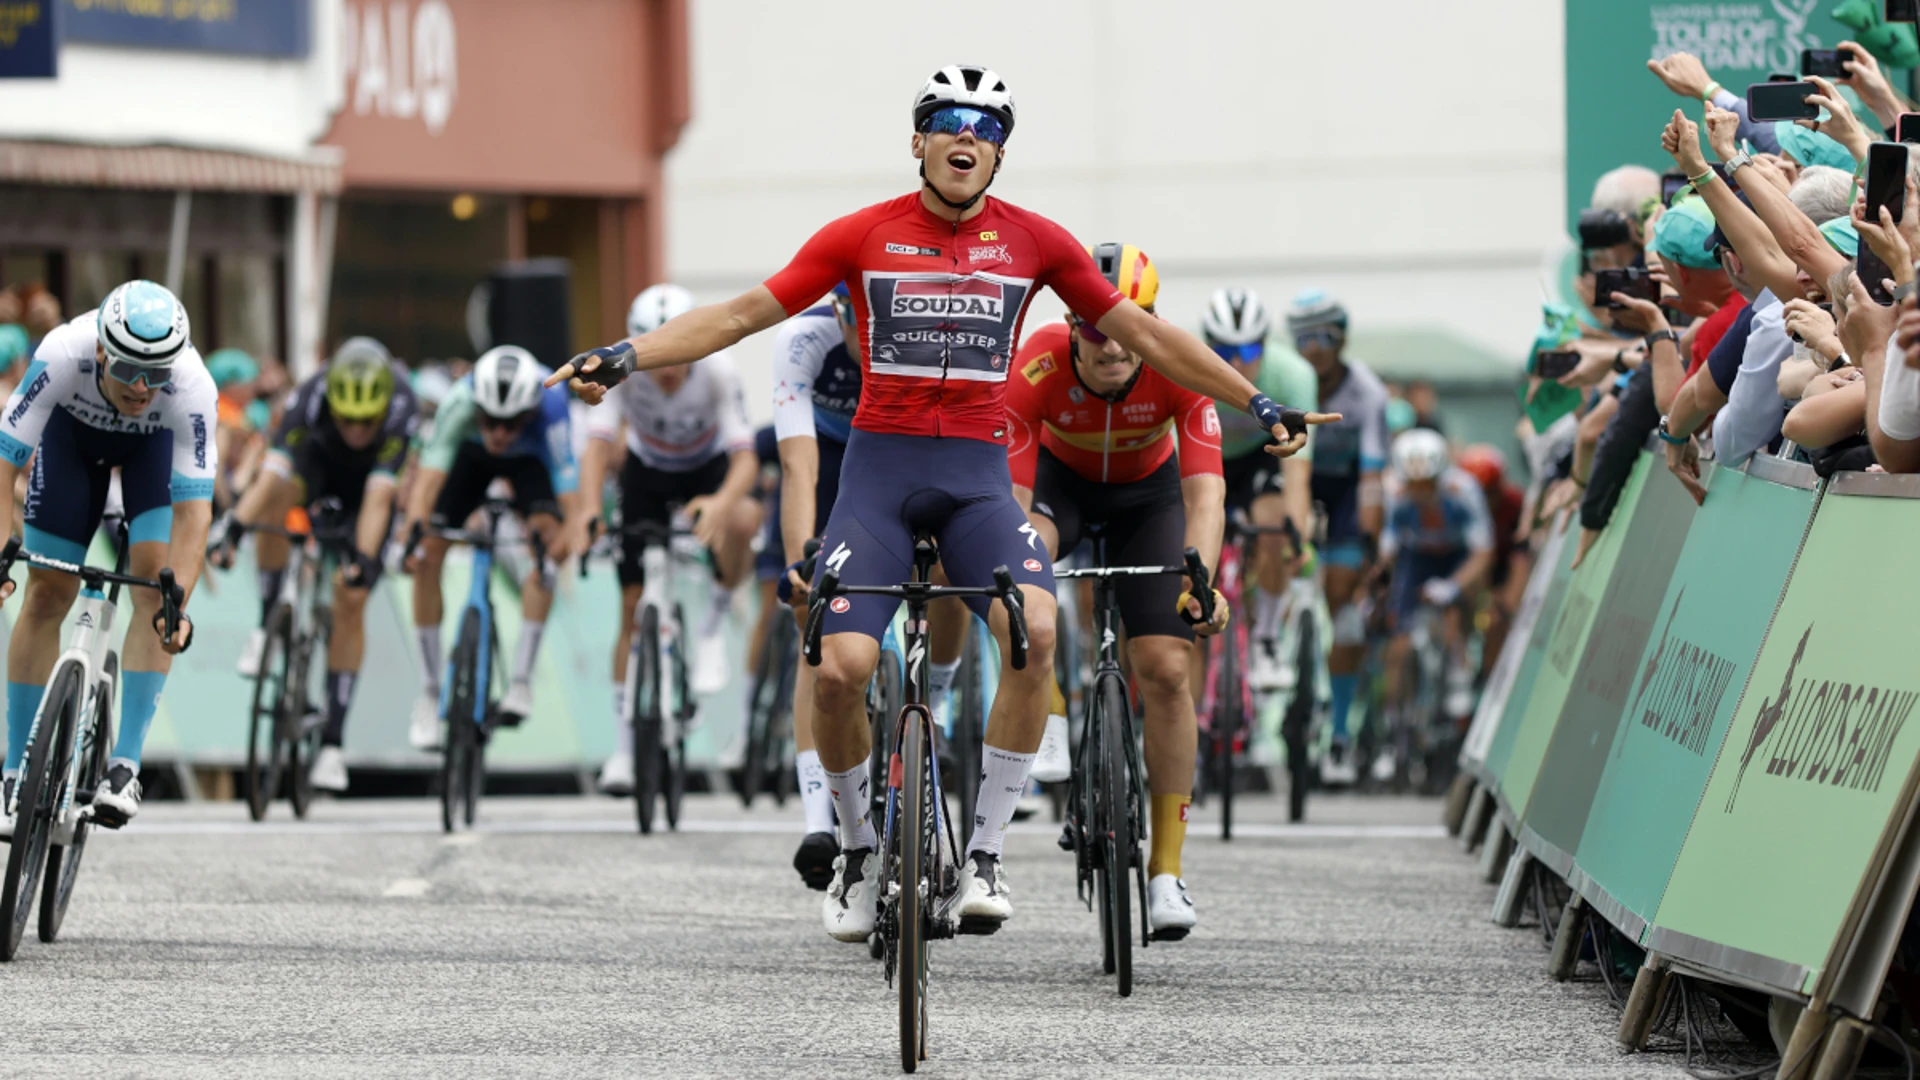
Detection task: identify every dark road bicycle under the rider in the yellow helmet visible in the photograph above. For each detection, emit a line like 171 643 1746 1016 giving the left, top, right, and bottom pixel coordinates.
226 502 355 821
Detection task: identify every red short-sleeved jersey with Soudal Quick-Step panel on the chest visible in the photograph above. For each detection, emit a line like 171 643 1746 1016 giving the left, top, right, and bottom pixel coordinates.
766 192 1121 442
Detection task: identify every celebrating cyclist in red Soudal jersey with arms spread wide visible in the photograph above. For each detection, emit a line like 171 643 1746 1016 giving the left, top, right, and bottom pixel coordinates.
551 65 1334 942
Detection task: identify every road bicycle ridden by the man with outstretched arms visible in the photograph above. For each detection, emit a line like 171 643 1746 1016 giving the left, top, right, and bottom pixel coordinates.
804 532 1027 1072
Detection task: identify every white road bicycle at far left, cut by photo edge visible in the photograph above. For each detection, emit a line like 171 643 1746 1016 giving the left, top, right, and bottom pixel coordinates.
0 521 186 961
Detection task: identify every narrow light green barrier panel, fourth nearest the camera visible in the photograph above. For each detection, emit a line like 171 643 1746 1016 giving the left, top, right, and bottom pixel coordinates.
1500 454 1667 814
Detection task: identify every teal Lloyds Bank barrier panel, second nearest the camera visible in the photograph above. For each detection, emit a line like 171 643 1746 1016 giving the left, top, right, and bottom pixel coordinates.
1569 463 1816 938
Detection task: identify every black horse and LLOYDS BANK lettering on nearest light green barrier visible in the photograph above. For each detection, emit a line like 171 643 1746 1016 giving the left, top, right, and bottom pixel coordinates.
1726 625 1920 813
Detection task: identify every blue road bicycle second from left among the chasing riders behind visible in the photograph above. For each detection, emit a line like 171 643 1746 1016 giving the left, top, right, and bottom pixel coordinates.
416 498 547 832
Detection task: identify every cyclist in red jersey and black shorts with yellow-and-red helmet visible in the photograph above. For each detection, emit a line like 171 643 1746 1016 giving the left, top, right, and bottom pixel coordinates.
1006 244 1227 942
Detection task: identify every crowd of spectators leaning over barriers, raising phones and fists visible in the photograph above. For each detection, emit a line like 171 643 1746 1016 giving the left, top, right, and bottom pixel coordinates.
1521 42 1920 555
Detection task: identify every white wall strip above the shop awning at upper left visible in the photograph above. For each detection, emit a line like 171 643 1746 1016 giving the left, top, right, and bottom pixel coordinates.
0 0 342 156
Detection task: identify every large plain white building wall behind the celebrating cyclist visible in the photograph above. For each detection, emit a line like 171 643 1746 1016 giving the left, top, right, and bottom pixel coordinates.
668 0 1565 415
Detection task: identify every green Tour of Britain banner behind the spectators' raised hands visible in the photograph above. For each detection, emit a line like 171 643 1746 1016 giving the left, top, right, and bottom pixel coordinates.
1567 0 1880 233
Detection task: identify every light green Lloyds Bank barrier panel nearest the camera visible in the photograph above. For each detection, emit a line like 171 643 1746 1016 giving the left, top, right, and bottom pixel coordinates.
1647 477 1920 994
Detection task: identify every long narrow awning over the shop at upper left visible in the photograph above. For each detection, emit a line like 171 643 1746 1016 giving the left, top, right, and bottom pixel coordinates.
0 138 342 194
